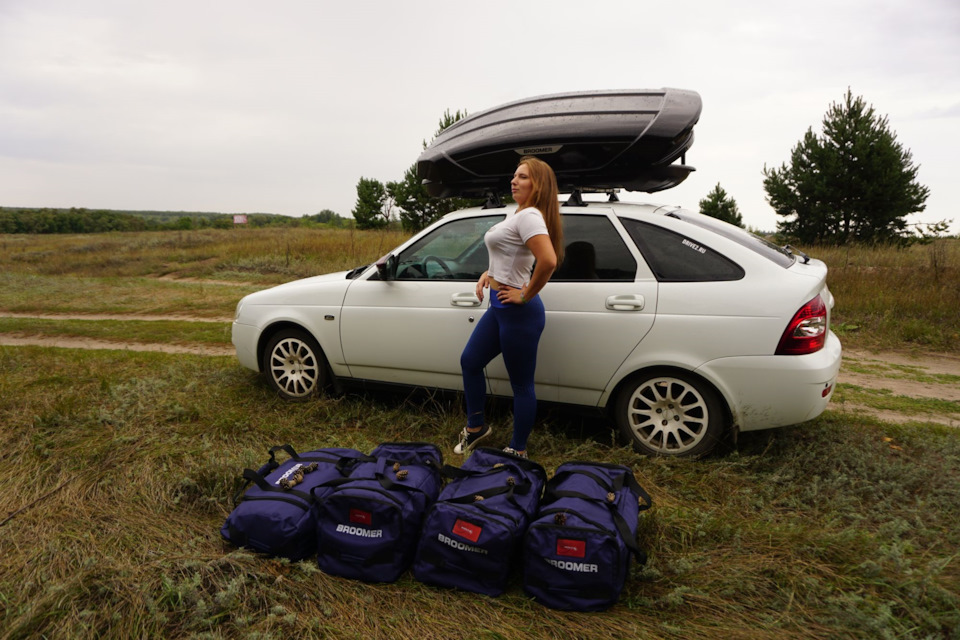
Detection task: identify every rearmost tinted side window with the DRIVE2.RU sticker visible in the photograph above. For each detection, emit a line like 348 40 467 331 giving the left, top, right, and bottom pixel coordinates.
620 218 744 282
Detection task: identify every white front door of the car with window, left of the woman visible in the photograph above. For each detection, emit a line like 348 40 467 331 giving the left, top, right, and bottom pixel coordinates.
340 212 504 389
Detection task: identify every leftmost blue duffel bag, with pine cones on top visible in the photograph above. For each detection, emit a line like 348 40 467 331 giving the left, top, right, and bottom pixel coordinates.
220 444 364 560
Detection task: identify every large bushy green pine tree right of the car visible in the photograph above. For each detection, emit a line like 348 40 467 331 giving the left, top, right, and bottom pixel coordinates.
763 89 930 244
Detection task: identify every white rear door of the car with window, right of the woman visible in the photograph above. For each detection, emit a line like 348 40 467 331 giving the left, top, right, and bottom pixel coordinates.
487 206 657 405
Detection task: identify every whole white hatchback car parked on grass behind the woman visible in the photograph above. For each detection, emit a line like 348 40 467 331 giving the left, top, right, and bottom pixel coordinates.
233 201 841 455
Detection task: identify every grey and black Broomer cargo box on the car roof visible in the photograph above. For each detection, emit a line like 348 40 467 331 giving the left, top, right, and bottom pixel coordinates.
417 89 701 197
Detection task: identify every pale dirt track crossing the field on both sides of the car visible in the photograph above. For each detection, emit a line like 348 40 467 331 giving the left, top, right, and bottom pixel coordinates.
0 312 960 427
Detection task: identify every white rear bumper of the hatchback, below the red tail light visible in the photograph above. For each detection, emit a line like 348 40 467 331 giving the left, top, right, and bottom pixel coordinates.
697 331 842 431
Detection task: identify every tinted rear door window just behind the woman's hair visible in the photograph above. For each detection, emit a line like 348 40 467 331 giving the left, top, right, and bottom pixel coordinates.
551 214 637 282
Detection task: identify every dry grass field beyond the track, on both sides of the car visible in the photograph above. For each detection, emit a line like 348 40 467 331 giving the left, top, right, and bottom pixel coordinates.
0 229 960 352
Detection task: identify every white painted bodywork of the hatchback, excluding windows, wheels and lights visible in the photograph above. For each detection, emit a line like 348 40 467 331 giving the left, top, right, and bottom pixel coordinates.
233 203 841 444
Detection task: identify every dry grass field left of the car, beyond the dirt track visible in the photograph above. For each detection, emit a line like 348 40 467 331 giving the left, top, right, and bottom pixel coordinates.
0 229 407 318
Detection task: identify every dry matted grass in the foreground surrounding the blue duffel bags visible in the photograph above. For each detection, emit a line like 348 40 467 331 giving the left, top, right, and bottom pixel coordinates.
0 348 960 638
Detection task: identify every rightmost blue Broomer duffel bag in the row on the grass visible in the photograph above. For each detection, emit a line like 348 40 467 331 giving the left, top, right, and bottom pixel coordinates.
523 462 651 611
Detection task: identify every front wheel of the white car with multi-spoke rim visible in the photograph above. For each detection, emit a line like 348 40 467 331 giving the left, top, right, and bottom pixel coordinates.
263 329 328 400
